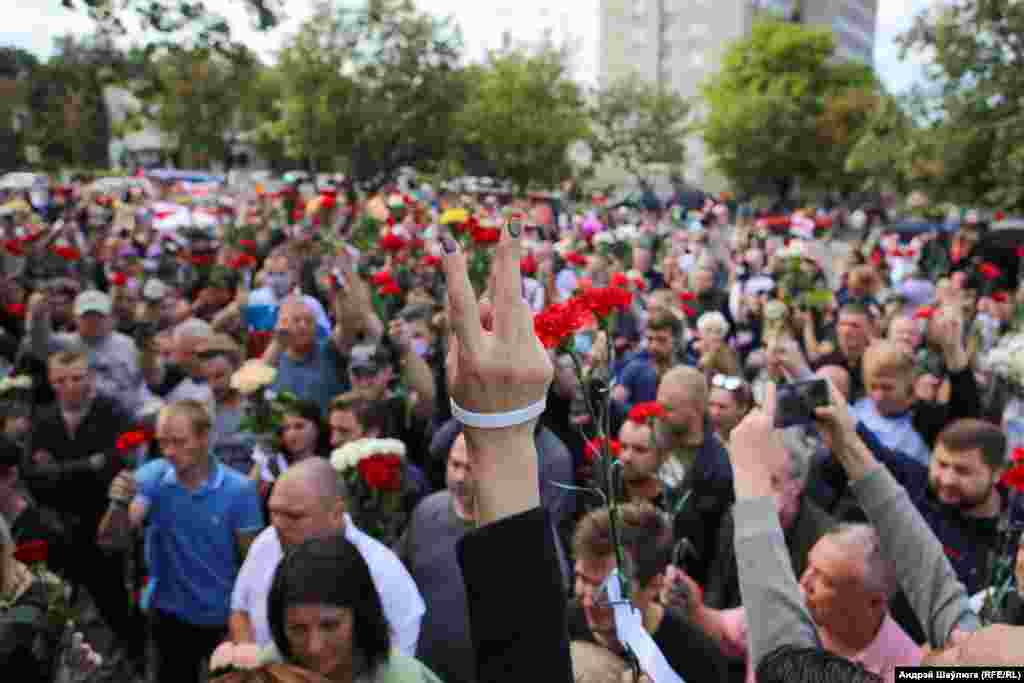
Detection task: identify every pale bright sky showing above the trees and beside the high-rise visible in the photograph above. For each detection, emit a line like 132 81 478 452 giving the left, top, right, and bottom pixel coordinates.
0 0 938 92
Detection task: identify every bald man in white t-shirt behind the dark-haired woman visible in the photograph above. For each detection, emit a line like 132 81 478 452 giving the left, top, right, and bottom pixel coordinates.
229 458 426 656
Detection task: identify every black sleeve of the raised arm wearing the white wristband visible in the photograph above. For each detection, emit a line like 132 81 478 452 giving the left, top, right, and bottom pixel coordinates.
457 508 572 683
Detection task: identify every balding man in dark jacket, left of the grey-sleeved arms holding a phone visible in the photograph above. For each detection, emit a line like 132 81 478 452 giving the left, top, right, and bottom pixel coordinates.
655 366 733 584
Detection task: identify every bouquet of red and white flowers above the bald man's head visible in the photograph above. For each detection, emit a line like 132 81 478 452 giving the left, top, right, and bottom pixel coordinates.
331 438 413 546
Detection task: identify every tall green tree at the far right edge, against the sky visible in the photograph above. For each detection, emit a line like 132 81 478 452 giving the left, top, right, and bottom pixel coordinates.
900 0 1024 210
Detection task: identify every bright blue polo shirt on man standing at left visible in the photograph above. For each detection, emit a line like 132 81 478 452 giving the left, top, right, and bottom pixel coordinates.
135 458 264 626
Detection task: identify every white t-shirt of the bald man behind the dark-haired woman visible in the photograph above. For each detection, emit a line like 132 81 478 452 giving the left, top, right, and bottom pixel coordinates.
231 515 427 656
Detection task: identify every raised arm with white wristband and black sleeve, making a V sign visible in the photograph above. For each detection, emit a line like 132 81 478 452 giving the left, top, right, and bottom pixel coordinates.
442 224 572 683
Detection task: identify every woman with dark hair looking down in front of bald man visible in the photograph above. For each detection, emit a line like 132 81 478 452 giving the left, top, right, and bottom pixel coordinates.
267 536 440 683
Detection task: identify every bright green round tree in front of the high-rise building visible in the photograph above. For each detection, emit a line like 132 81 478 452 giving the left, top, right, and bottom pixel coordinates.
701 20 877 198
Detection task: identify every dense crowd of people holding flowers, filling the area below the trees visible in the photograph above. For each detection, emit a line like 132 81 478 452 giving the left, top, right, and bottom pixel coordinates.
0 178 1024 683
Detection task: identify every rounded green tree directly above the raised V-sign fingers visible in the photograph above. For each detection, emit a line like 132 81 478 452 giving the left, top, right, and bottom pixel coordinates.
458 47 590 190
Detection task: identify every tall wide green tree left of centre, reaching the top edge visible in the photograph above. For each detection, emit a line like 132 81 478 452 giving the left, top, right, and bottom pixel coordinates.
262 0 465 188
